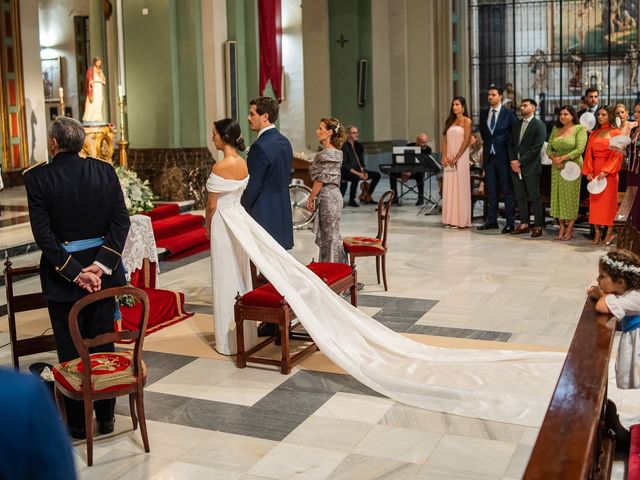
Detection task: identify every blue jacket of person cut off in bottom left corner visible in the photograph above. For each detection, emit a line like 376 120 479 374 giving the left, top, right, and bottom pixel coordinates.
0 369 76 480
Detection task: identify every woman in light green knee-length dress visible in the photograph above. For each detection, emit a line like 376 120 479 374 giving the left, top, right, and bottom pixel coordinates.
547 105 587 240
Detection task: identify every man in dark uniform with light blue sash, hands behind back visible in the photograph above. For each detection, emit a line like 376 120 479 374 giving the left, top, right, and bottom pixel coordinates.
23 117 130 438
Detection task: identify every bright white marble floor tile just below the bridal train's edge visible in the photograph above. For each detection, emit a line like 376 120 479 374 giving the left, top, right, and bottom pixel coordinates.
314 392 394 423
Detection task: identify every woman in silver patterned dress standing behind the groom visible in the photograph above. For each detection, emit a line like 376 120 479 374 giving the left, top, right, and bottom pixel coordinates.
307 118 347 263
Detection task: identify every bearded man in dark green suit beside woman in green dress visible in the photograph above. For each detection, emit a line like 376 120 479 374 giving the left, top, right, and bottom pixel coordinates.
509 98 547 237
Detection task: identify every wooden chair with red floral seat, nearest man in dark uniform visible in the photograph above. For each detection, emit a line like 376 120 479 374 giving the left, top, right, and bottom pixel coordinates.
53 287 149 466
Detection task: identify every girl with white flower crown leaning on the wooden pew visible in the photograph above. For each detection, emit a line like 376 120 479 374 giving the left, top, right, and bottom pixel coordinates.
588 250 640 389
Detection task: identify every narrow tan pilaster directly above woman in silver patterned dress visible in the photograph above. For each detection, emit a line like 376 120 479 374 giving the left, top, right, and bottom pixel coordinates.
302 0 331 151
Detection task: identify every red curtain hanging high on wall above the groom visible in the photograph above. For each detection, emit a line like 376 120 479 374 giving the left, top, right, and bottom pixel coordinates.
258 0 282 102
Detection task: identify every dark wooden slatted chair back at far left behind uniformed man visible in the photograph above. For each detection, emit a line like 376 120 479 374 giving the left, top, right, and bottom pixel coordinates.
4 258 56 369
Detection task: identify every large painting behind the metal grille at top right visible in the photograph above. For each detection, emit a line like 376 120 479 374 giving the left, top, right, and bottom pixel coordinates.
552 0 638 57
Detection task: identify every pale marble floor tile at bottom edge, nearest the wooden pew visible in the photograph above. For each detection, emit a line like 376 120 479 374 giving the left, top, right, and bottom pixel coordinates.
423 434 517 477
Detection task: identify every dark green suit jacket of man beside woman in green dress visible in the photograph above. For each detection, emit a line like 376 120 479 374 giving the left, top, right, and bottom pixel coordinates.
509 117 547 177
